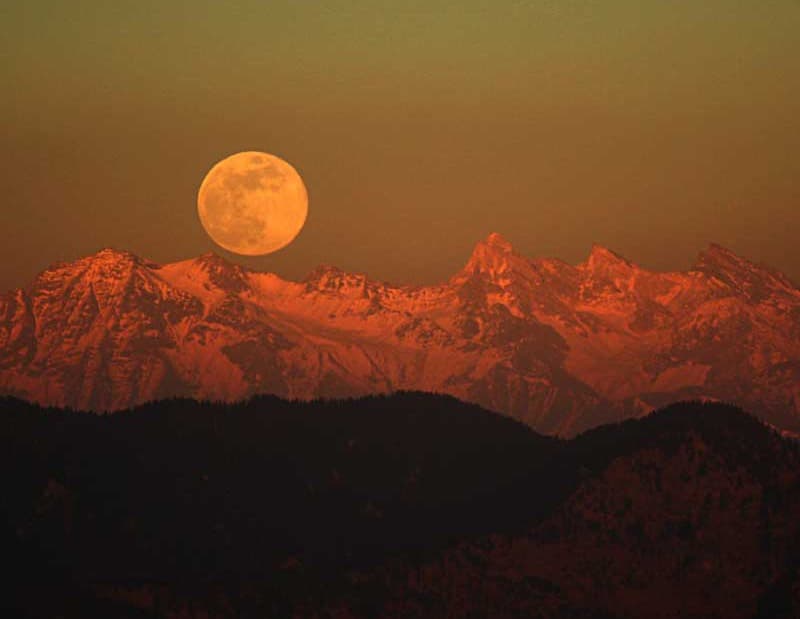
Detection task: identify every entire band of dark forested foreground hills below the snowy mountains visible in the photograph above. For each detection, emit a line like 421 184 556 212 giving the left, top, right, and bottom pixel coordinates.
0 393 800 618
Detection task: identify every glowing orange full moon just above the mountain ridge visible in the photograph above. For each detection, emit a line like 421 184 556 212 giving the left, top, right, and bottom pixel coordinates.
197 151 308 256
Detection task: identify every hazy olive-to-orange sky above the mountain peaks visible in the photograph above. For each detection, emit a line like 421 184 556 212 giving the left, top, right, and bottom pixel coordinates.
0 0 800 289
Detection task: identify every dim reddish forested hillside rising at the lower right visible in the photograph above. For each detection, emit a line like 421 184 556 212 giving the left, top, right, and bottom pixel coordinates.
341 403 800 619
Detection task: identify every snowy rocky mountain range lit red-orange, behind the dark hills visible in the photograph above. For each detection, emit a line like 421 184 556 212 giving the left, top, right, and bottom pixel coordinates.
0 234 800 435
